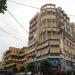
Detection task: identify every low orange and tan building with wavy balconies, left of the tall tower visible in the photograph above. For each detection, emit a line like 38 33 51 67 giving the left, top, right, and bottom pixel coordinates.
3 47 28 69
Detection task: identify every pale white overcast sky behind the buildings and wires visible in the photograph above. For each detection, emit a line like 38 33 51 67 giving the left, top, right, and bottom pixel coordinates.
0 0 75 61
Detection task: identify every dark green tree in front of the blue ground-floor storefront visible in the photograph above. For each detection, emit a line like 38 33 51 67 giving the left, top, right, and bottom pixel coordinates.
40 60 52 75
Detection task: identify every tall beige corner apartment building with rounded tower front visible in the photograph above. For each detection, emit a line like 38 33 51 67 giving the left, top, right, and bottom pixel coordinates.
28 4 75 71
